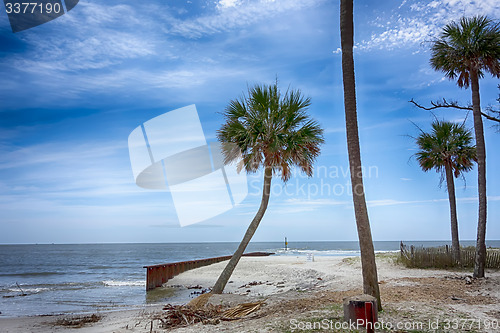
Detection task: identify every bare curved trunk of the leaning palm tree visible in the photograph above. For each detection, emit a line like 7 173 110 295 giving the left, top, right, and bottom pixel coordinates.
212 166 273 294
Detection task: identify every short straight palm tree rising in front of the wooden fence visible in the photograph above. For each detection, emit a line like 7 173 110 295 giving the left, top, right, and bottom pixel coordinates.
416 120 477 262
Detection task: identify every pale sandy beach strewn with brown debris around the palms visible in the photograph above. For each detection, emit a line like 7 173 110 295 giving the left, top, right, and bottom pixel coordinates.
0 253 500 333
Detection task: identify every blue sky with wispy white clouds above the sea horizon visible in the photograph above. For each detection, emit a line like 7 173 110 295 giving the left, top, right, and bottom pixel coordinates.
0 0 500 244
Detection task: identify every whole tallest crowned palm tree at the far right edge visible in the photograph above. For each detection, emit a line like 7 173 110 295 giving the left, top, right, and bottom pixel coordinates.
430 16 500 277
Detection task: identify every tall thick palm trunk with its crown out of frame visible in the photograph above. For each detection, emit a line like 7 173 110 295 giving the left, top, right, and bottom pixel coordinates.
340 0 382 311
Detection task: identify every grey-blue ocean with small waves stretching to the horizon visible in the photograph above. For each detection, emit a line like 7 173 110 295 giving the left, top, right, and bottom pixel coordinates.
0 241 500 318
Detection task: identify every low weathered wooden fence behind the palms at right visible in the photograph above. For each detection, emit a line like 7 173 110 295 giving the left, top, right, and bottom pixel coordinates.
400 242 500 269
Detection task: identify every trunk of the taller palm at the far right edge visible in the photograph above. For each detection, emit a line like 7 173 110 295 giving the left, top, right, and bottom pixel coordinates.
470 71 487 278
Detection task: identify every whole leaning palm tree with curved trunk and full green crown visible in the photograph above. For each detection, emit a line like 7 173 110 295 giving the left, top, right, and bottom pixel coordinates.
212 82 323 294
